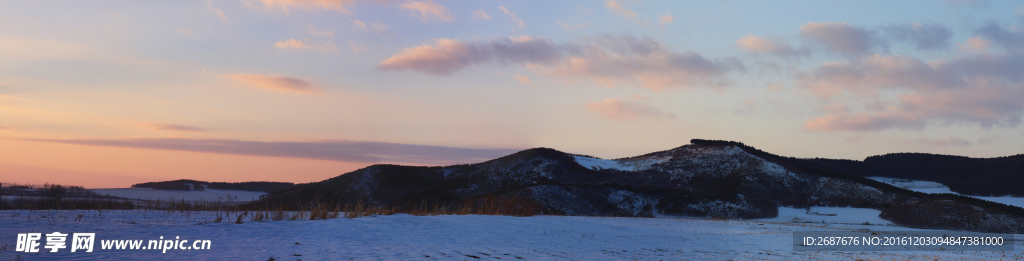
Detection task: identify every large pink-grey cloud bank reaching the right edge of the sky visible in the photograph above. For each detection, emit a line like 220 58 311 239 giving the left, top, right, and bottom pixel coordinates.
798 54 1024 131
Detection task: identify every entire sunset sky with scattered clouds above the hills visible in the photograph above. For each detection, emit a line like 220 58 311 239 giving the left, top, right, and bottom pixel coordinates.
0 0 1024 187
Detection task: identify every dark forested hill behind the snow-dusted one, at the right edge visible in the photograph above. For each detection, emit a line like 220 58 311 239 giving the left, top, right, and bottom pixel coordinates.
806 153 1024 197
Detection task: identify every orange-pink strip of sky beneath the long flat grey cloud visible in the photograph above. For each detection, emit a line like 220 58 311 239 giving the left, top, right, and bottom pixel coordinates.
0 140 369 188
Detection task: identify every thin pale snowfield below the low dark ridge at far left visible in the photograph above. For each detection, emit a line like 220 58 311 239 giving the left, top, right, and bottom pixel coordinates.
90 187 265 202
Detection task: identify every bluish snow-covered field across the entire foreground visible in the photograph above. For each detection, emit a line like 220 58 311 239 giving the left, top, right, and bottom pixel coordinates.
0 208 1024 260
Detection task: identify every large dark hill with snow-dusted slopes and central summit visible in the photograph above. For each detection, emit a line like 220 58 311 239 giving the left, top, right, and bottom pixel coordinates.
256 139 1024 233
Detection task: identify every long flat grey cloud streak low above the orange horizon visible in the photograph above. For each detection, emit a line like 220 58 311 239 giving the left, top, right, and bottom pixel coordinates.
27 138 517 165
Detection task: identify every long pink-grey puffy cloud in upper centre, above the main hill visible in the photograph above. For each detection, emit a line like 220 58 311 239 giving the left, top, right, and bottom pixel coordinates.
378 35 743 90
